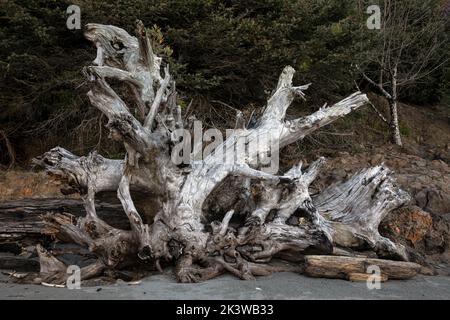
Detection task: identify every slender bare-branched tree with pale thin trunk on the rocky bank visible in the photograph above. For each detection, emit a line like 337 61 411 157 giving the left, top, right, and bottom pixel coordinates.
358 0 448 146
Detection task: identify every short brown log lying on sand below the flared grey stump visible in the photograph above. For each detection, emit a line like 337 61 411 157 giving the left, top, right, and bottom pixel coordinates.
304 255 421 280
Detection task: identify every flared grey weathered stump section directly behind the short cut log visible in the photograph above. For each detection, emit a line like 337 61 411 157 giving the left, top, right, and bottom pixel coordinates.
313 166 410 261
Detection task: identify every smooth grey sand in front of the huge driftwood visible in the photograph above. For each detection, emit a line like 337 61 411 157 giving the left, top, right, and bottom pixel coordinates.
0 272 450 300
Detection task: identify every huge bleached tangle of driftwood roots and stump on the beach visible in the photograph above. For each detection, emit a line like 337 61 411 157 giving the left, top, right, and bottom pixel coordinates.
8 22 420 283
